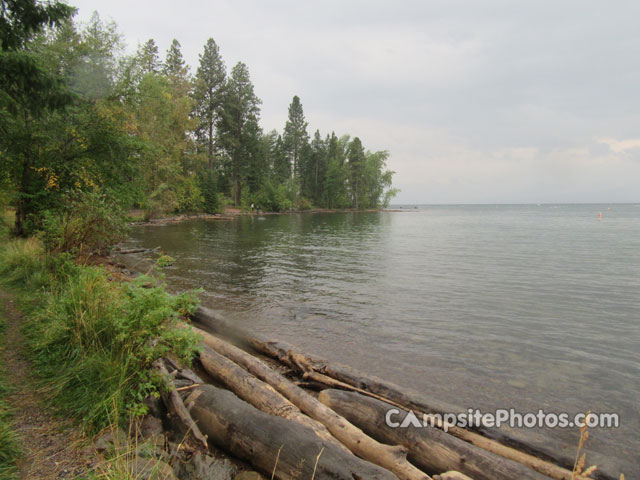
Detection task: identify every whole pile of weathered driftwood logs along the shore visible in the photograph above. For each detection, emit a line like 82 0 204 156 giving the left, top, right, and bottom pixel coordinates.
158 308 596 480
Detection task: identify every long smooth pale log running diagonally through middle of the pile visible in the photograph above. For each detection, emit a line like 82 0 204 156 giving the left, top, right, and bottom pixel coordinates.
192 332 430 480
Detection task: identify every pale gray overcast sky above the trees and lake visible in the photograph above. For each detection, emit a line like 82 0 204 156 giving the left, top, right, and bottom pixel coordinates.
69 0 640 203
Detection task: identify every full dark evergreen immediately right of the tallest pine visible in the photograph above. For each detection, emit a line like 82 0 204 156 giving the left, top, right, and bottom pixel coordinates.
218 62 264 205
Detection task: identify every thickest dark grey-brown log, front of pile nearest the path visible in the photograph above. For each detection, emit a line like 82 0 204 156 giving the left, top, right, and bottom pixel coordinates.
186 385 397 480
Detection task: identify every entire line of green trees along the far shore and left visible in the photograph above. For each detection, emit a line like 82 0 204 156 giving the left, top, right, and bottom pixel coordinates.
0 0 396 234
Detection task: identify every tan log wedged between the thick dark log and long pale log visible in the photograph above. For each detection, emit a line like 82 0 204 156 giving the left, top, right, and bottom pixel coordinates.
200 347 348 452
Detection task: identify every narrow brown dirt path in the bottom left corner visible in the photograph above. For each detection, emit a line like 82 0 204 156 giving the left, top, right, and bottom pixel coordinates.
0 290 94 480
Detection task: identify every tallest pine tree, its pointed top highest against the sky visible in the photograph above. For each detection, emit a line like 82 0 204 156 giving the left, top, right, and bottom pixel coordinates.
193 38 226 170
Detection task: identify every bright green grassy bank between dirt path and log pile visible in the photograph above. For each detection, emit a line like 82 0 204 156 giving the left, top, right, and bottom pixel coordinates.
0 234 197 433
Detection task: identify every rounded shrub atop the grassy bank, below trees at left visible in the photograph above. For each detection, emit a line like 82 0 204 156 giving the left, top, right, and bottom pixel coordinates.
43 192 127 254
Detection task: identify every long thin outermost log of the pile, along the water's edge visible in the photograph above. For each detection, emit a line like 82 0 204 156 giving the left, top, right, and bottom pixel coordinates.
192 308 592 480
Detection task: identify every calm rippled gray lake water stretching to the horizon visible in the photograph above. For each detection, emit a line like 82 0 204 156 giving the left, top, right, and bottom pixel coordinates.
126 205 640 478
